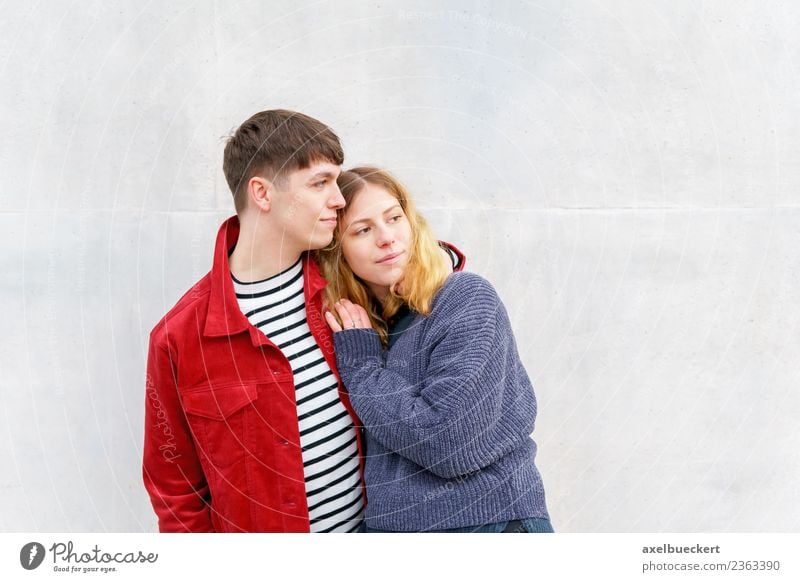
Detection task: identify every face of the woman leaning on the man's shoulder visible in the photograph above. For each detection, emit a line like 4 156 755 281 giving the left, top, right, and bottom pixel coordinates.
341 183 411 301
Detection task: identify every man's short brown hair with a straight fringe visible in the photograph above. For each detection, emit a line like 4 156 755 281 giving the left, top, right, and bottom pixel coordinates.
222 109 344 213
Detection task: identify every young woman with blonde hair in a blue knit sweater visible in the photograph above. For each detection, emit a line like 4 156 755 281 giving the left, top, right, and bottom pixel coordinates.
320 167 553 532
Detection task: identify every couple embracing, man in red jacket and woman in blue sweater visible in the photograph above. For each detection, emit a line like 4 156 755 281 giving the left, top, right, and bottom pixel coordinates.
143 110 552 532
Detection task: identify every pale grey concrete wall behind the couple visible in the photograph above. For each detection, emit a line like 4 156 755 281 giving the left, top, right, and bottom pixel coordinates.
0 0 800 532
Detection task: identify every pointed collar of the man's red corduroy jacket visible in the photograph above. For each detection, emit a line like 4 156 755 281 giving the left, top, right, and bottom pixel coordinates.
203 216 328 344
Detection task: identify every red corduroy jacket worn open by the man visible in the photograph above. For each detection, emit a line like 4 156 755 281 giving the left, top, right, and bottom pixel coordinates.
143 217 363 532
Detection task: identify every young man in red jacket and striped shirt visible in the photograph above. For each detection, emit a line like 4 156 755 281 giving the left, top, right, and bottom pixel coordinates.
143 110 365 532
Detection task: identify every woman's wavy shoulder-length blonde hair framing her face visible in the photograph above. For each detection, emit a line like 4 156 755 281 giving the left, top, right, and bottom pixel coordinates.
317 166 450 344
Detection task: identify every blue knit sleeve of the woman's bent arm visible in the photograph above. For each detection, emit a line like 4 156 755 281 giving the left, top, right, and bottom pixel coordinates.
334 273 536 478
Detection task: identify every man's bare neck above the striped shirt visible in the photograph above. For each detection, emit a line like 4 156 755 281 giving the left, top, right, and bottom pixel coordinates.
229 226 302 282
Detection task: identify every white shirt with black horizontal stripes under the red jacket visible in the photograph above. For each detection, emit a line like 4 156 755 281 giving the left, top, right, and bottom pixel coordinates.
233 260 364 532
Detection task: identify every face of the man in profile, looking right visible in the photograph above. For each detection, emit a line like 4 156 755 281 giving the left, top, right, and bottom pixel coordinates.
272 161 344 253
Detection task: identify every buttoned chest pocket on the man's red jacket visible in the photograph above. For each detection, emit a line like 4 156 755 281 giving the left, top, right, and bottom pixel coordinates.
183 384 258 471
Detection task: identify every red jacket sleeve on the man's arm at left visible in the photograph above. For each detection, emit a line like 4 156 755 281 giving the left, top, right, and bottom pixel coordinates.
142 336 214 533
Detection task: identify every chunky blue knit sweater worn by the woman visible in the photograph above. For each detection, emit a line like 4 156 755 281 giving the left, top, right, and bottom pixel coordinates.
334 272 549 531
